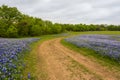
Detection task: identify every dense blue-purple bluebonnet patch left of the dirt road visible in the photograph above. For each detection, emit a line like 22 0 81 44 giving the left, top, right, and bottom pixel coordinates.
0 38 38 80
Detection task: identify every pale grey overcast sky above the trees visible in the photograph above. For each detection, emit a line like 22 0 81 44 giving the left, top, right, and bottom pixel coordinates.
0 0 120 24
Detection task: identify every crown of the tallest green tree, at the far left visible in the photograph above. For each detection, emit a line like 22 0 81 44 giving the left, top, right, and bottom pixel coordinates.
0 5 22 26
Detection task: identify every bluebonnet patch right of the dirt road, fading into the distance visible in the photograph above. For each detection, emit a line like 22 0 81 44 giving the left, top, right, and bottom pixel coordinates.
65 35 120 61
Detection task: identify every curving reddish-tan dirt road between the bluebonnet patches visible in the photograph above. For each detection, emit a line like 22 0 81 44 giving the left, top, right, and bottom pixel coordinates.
36 38 119 80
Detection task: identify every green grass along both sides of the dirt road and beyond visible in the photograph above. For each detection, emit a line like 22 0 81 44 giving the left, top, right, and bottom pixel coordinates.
23 31 120 80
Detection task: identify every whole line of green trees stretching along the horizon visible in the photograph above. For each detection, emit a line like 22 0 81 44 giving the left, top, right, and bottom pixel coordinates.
0 5 120 37
